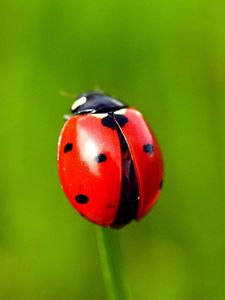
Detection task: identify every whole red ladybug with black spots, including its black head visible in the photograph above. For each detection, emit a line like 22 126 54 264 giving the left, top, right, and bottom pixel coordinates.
57 92 163 228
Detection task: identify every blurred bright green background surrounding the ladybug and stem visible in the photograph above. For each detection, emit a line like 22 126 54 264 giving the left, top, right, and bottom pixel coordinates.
0 0 225 300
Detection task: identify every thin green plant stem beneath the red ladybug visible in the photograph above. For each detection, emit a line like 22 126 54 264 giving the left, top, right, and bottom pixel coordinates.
97 226 130 300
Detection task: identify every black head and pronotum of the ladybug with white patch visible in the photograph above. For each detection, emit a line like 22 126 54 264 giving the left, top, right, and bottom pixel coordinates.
71 92 127 114
